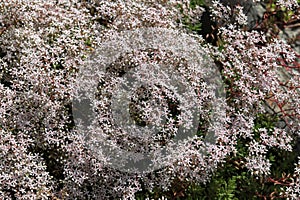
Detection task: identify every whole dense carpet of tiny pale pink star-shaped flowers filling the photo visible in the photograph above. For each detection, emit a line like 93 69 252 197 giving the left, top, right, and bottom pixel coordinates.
0 0 300 199
